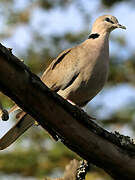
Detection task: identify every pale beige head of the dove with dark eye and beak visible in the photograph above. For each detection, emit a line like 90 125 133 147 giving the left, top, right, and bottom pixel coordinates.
92 15 126 34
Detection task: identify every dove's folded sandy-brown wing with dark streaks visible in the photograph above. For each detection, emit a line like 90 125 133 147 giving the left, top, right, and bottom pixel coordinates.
41 47 79 92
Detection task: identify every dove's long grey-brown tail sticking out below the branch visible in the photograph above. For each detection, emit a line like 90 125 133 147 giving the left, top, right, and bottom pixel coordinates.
0 112 35 150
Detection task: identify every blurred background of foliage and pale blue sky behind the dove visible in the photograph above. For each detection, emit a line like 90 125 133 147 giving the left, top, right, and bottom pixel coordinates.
0 0 135 180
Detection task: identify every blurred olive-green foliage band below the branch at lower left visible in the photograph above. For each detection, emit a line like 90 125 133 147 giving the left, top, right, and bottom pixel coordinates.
0 143 75 177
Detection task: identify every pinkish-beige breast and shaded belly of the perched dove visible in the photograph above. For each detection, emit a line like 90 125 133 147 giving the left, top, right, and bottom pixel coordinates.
58 37 109 106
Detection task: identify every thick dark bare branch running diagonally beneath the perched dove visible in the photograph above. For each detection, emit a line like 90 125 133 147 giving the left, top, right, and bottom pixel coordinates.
0 44 135 180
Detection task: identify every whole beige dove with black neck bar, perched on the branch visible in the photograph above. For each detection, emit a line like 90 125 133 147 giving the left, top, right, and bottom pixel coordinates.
0 15 125 149
